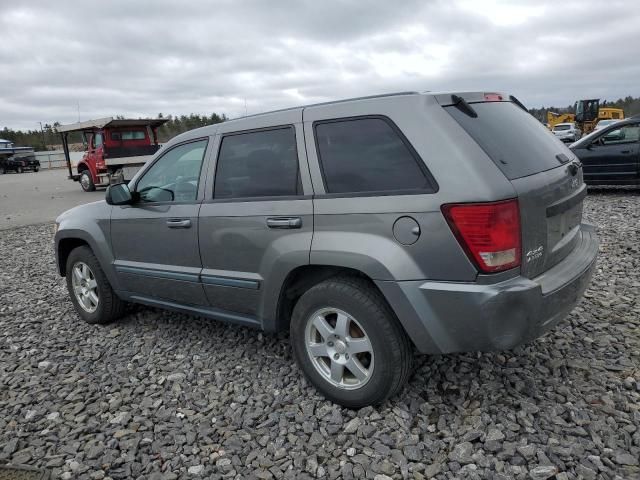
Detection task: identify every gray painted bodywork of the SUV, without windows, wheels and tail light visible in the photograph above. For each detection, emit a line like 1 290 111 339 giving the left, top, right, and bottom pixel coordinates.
56 93 597 352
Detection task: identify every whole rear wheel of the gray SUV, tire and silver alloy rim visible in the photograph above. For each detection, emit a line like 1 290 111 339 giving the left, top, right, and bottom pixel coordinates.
291 277 412 408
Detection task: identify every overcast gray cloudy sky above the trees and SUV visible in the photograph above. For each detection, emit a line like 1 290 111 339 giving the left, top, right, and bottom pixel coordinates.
0 0 640 129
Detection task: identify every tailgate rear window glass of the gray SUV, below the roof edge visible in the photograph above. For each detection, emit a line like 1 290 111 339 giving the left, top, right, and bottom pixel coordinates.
445 102 562 180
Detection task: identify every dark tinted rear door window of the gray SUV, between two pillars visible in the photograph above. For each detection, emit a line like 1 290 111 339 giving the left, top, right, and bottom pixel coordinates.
214 127 302 198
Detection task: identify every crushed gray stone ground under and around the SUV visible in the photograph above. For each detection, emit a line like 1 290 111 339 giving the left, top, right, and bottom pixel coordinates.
0 190 640 480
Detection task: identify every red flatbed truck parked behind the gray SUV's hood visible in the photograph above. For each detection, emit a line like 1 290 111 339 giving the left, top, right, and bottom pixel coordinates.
58 117 167 192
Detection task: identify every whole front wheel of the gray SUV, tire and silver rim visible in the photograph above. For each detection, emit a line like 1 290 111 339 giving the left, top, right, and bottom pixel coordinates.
66 246 125 323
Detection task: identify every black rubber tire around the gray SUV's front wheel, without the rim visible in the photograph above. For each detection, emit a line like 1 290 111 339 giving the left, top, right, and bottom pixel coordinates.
66 246 126 324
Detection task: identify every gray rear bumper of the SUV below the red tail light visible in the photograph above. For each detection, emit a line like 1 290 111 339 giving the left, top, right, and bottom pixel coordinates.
376 224 598 353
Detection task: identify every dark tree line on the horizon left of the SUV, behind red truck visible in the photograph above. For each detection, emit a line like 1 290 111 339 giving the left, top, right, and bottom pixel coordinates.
0 113 227 151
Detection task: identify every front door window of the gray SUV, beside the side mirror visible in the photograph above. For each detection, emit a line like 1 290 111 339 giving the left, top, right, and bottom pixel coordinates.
136 140 207 202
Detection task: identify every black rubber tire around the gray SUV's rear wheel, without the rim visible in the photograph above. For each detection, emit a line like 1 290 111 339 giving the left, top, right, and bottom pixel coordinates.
290 276 413 408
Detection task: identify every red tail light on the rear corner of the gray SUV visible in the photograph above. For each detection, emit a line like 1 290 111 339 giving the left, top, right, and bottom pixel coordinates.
442 199 521 273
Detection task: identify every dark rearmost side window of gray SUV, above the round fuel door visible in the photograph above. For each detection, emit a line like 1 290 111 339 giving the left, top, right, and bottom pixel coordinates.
315 117 436 193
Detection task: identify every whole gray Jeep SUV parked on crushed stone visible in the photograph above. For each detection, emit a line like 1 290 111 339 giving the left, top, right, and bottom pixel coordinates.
55 92 598 408
